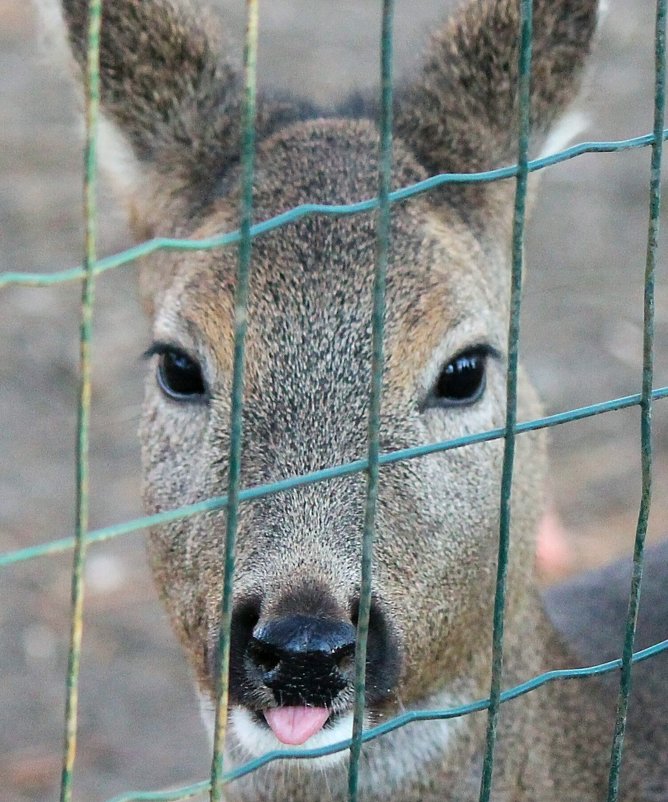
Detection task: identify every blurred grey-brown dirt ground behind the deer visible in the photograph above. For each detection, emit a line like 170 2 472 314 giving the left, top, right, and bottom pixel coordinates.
0 0 668 802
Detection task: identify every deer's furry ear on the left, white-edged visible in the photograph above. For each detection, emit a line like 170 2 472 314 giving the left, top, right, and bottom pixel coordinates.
40 0 240 227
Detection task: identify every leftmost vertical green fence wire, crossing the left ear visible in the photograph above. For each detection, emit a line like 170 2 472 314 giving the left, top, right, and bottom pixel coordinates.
60 0 102 802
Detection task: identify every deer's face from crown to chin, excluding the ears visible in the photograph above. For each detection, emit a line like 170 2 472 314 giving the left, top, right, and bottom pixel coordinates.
142 121 540 764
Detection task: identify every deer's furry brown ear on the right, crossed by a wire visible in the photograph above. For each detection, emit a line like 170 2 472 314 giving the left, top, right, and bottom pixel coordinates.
396 0 598 178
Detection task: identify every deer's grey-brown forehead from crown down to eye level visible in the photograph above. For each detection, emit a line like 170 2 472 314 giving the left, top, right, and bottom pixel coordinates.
156 120 504 392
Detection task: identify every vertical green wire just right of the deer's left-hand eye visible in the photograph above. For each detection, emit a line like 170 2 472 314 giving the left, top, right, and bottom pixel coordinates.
210 0 258 802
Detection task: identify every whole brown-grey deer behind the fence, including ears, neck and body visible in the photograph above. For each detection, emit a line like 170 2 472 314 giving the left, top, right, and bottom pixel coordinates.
44 0 668 802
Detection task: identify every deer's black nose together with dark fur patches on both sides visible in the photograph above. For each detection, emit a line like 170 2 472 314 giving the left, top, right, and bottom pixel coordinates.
227 591 401 710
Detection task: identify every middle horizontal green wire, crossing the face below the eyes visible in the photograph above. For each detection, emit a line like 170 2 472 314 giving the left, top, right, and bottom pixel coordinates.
0 386 668 569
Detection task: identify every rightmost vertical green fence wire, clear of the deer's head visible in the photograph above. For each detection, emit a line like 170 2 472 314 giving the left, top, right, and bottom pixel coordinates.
607 0 666 802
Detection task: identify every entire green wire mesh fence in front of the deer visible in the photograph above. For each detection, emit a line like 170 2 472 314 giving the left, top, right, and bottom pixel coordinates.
0 0 668 802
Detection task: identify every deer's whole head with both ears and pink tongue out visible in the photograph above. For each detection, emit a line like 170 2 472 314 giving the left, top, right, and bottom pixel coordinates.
52 0 597 780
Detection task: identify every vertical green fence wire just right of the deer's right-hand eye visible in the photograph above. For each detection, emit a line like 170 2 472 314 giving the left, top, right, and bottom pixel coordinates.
479 0 533 802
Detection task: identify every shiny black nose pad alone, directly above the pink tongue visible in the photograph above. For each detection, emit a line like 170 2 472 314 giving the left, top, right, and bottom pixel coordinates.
246 615 355 707
